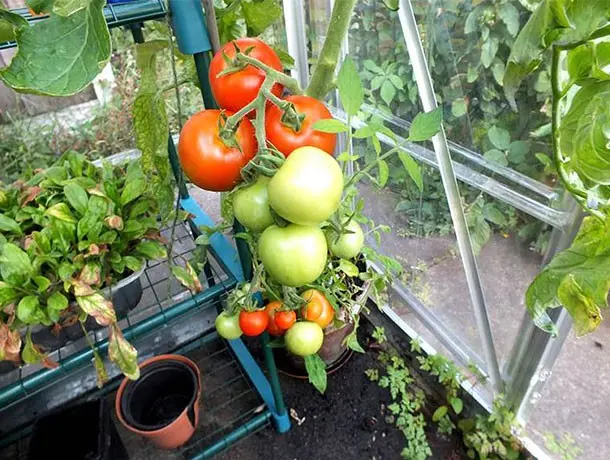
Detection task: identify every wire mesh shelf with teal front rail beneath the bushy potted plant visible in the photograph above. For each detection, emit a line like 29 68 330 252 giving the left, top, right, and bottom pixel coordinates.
0 219 236 444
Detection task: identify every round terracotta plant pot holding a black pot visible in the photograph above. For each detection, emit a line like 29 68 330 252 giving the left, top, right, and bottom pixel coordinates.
115 355 201 449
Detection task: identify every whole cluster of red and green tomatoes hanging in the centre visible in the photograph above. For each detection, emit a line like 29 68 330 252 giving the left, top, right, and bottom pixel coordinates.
195 38 364 356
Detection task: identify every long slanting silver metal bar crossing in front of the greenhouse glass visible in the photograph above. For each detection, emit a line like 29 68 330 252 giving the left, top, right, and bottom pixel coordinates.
398 0 502 392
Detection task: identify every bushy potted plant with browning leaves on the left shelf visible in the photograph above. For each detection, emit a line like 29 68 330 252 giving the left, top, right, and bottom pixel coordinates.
0 152 192 378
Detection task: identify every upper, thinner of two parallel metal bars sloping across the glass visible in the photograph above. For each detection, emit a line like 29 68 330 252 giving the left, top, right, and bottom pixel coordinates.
362 104 559 200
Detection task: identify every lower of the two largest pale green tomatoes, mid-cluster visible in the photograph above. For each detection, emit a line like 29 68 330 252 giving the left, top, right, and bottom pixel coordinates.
258 224 328 287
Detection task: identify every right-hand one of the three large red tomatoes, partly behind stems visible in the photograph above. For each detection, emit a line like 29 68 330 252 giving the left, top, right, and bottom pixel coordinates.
265 96 337 156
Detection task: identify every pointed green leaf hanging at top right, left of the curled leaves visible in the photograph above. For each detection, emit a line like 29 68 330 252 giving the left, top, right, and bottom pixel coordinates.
504 1 552 110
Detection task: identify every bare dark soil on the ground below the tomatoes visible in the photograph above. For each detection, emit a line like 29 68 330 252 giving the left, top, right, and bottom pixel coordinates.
223 321 467 460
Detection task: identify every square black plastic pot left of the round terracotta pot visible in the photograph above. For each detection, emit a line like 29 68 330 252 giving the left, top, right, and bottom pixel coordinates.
27 399 129 460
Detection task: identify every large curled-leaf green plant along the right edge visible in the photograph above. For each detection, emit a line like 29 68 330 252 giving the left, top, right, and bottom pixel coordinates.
504 0 610 335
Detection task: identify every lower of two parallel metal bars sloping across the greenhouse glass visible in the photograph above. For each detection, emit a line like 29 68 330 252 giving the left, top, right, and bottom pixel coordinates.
331 108 571 229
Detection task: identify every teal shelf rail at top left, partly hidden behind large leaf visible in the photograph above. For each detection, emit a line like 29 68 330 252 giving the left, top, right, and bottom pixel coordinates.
0 0 167 50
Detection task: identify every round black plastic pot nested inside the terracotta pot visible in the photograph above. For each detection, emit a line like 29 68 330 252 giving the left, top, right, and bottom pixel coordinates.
121 361 198 431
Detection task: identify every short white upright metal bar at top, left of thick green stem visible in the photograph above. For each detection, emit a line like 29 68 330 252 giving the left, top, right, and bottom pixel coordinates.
283 0 309 88
